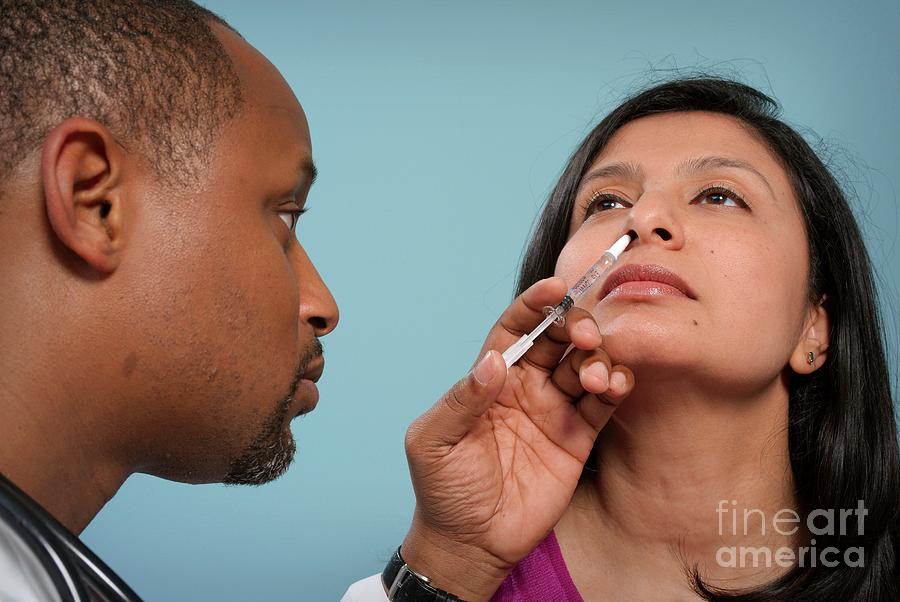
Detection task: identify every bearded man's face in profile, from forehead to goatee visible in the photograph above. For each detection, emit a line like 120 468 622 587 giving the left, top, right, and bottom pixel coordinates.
123 28 337 483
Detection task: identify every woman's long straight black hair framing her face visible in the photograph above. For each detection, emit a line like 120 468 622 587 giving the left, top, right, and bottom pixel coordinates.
517 77 900 602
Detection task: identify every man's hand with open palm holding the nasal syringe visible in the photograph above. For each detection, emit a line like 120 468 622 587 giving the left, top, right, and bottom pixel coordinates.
401 278 634 600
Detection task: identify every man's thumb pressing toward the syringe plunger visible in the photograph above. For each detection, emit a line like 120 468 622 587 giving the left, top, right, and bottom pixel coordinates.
420 350 506 445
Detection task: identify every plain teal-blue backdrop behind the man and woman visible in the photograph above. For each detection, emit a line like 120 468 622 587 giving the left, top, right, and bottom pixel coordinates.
84 0 900 601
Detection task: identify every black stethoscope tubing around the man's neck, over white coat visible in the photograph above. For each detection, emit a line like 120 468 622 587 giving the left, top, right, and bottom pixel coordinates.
0 474 141 602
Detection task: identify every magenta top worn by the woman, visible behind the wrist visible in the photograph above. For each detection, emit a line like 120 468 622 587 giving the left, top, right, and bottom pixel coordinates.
493 531 584 602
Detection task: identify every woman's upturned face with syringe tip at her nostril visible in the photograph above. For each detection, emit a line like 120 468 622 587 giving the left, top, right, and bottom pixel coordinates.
556 112 809 394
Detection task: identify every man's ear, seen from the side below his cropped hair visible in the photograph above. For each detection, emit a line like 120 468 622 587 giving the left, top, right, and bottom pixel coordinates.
41 117 126 274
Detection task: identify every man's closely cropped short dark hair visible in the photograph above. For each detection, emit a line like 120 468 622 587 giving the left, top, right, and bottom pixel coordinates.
0 0 243 192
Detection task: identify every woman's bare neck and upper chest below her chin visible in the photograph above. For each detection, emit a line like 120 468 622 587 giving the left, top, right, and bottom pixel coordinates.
557 372 800 599
